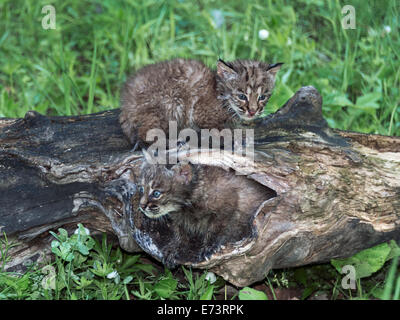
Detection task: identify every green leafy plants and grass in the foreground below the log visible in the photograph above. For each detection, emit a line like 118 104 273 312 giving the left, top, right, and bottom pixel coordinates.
0 225 400 300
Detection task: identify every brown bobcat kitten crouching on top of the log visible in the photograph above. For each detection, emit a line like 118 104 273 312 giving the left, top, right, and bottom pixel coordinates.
120 58 282 144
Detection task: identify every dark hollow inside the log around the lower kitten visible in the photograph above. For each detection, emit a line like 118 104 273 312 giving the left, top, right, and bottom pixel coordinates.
130 171 277 267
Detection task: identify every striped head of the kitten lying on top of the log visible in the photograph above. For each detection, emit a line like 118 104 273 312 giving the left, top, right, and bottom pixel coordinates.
217 60 283 120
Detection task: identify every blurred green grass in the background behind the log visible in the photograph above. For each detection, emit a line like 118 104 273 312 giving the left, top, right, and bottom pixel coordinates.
0 0 400 135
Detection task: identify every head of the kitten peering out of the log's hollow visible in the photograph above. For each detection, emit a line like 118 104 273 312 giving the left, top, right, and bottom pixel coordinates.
138 162 193 219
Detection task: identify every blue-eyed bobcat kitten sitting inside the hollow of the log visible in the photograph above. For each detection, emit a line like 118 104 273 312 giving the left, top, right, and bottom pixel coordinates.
138 158 275 242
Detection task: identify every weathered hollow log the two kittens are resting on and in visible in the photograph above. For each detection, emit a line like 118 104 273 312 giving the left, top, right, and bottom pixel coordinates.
0 87 400 286
